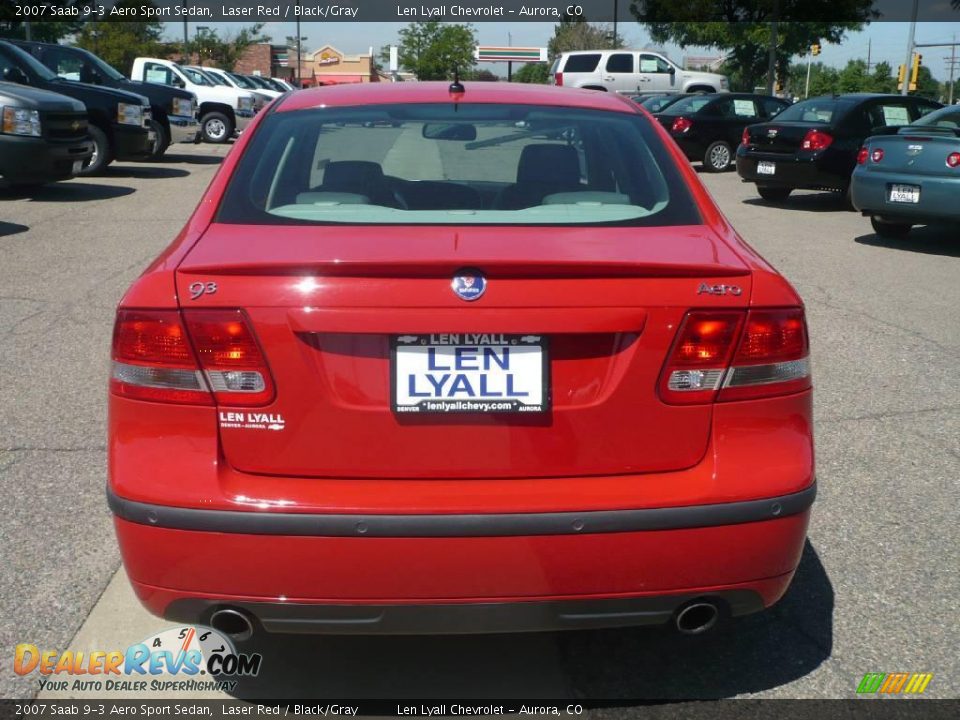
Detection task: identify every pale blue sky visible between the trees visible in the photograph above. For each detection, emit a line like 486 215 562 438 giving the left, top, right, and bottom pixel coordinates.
165 22 960 81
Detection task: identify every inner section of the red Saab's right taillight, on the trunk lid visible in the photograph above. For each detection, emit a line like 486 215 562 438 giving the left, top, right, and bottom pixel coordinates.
660 310 743 405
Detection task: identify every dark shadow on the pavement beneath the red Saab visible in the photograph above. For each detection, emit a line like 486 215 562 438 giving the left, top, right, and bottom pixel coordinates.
221 542 834 705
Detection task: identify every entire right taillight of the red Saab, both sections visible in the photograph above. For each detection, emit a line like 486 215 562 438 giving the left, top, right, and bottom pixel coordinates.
659 308 810 405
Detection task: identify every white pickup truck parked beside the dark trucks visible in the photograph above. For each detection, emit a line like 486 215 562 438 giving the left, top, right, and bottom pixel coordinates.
130 57 254 143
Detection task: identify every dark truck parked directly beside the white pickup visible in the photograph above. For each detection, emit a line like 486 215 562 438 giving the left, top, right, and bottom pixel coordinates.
11 40 200 160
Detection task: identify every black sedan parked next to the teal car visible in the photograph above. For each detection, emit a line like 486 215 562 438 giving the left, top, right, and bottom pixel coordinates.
737 93 942 201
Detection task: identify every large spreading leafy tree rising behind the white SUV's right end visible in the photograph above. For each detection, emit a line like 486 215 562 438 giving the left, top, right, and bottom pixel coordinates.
630 0 876 90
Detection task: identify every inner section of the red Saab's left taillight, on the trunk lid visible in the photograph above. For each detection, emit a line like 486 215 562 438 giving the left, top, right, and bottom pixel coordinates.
184 310 273 405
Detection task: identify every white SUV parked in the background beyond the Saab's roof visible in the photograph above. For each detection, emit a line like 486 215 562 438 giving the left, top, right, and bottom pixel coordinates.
550 50 730 95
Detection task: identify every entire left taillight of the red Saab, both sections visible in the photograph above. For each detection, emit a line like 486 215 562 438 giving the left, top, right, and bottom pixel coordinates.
110 310 274 406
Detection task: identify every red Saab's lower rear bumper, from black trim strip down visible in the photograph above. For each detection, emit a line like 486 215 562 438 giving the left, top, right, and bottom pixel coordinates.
116 485 816 633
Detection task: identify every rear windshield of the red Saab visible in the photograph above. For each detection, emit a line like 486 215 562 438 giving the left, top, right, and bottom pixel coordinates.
218 103 700 225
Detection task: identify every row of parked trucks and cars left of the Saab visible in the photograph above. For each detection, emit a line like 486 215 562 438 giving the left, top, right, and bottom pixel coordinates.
0 40 292 185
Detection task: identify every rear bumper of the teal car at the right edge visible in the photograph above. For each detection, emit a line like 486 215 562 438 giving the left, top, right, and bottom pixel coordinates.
850 170 960 223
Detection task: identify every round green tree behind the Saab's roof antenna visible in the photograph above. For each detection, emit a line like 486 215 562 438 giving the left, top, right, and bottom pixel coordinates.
388 21 477 80
